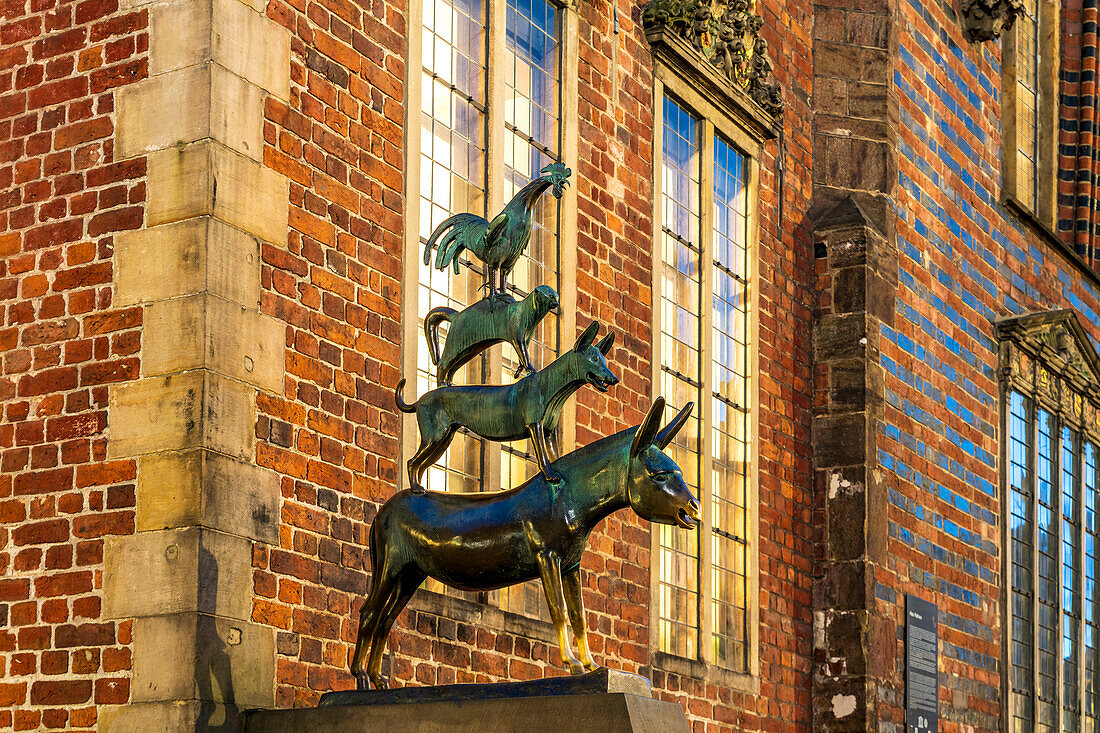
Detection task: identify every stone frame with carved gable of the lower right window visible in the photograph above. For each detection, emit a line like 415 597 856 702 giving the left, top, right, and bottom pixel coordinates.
996 309 1100 730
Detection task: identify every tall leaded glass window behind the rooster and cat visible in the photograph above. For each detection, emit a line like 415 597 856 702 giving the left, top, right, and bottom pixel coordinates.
402 0 565 617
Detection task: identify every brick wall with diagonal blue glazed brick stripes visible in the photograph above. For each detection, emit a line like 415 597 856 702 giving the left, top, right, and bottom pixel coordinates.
875 0 1100 732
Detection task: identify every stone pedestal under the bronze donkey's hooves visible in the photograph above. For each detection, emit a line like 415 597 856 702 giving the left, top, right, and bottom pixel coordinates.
244 670 689 733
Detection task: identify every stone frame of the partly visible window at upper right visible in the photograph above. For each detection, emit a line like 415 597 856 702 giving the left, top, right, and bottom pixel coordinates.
1001 0 1060 230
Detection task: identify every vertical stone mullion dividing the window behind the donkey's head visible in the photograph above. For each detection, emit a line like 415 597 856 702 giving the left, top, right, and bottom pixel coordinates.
699 118 717 661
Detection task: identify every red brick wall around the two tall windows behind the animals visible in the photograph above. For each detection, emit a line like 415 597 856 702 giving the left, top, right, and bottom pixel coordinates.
253 0 811 731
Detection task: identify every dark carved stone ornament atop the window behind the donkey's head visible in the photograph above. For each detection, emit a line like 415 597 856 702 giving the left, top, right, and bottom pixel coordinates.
641 0 783 119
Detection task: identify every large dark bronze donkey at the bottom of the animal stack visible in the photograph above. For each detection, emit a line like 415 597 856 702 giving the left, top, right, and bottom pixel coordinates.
351 397 700 690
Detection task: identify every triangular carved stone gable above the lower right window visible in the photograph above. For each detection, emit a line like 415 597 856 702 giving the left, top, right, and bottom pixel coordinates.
996 310 1100 414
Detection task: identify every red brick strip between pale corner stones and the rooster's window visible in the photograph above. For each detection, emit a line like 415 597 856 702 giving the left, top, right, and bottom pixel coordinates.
253 0 408 707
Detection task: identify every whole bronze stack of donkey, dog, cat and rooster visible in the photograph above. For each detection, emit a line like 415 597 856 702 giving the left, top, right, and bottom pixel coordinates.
351 163 700 690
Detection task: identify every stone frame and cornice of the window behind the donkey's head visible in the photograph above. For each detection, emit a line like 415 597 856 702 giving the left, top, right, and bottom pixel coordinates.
648 37 776 693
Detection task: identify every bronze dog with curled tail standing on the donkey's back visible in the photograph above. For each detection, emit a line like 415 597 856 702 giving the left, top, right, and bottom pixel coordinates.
394 322 618 493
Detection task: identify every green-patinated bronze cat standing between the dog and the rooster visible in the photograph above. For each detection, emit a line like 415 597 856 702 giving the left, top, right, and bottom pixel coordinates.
424 285 558 386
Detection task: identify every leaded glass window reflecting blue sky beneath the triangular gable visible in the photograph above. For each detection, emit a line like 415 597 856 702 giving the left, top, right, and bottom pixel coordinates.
1005 376 1100 733
